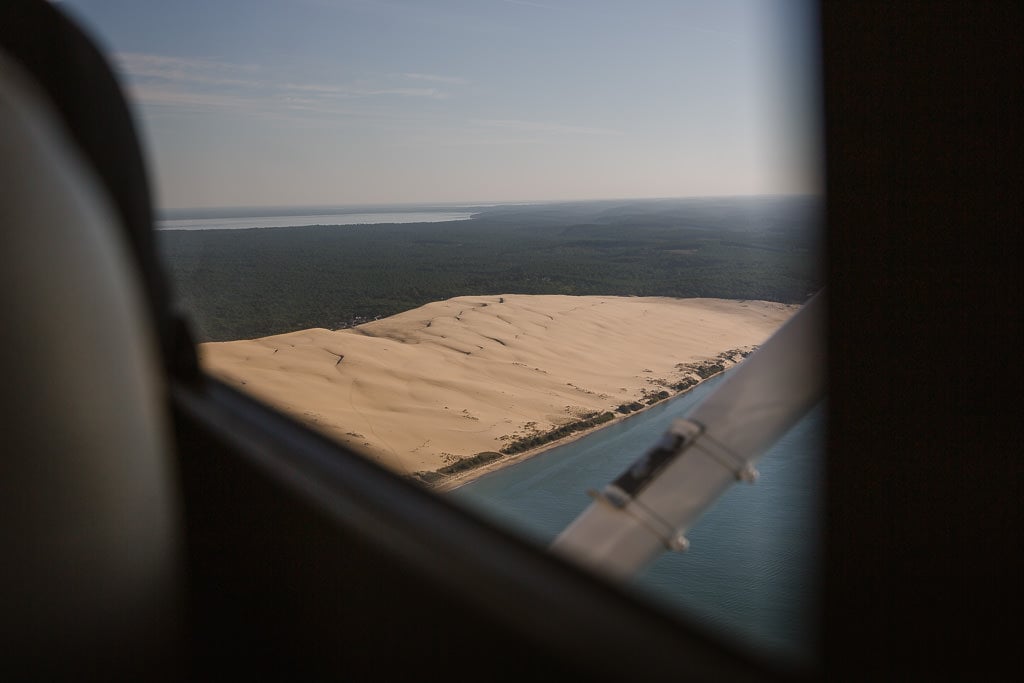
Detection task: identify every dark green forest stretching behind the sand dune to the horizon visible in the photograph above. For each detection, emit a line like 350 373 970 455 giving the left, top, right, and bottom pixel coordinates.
159 197 823 341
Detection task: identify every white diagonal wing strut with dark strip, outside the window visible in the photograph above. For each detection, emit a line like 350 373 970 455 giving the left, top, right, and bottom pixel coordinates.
552 292 825 579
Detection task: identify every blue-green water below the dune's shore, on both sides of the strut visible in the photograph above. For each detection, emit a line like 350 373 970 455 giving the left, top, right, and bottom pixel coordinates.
450 377 824 665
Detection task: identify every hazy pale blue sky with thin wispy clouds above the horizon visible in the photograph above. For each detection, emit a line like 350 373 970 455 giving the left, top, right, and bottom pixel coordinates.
54 0 821 209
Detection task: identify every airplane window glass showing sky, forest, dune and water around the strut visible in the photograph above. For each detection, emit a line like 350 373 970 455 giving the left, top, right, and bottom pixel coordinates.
59 0 824 665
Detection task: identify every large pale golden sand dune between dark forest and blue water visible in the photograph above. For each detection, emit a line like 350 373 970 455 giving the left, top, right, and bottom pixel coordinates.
201 295 798 481
